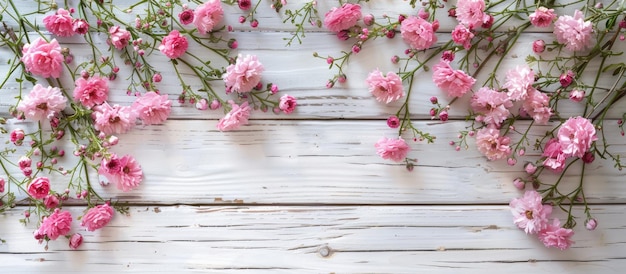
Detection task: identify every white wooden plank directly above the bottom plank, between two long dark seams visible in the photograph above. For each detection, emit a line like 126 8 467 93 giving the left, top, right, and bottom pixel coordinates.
0 120 626 204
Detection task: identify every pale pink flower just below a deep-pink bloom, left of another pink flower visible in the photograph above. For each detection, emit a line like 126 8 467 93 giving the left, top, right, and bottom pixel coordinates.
91 102 136 135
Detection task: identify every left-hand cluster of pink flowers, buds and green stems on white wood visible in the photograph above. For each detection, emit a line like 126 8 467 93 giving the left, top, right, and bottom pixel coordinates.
0 0 297 248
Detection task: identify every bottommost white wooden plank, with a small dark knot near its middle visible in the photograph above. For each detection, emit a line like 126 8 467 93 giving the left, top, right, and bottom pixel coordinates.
0 205 626 273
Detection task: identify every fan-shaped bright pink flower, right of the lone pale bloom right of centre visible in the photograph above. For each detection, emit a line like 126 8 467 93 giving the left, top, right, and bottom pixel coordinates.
433 60 476 97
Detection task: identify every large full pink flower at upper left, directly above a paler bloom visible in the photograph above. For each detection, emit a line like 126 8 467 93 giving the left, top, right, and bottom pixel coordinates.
21 37 65 78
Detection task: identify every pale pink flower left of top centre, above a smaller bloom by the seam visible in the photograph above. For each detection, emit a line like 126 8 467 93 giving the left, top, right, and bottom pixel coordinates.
222 54 265 93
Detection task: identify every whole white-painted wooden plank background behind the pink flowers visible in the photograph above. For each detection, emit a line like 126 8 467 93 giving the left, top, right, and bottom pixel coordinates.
0 0 626 273
